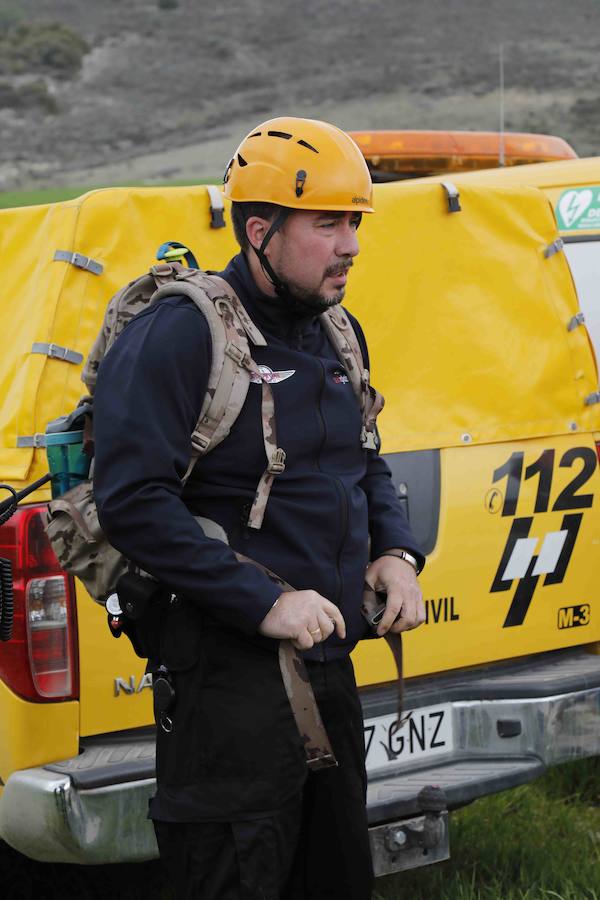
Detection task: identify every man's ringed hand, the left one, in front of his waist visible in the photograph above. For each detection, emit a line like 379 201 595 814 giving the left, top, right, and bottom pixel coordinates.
258 591 346 650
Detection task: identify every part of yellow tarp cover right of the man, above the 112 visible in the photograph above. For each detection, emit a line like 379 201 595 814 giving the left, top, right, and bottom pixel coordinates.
348 182 600 452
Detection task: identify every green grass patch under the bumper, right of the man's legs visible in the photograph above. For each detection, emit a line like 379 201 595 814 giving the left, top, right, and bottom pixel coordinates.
374 759 600 900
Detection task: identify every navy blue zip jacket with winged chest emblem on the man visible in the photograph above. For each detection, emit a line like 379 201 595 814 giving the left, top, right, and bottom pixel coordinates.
94 254 421 659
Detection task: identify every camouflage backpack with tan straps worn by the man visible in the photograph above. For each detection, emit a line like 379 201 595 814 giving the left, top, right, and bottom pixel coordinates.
46 262 383 604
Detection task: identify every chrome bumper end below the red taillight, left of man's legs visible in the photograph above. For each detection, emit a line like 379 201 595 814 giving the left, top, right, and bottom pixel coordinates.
0 728 158 864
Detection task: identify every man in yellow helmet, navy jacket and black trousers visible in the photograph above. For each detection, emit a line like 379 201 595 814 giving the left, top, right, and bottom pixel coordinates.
94 118 424 900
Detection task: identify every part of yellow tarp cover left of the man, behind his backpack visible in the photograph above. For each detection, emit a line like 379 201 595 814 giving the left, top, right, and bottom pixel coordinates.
0 187 236 483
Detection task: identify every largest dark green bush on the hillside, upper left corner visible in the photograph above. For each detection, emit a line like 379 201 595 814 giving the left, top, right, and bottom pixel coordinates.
0 24 90 78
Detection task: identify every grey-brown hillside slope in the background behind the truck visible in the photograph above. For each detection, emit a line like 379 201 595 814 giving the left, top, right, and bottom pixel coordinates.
0 0 600 189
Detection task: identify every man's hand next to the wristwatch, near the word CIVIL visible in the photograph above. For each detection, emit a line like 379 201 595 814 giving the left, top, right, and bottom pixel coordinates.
365 556 425 637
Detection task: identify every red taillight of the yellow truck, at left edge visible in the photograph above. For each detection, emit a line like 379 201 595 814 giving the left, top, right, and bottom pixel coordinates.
0 506 79 701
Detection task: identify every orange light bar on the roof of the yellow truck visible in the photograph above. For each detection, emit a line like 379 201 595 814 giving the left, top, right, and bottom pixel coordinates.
350 131 577 175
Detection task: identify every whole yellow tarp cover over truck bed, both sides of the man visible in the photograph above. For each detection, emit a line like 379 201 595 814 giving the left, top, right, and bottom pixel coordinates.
0 177 600 484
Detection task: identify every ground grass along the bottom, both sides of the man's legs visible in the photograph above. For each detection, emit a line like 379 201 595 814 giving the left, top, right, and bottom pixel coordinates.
0 759 600 900
